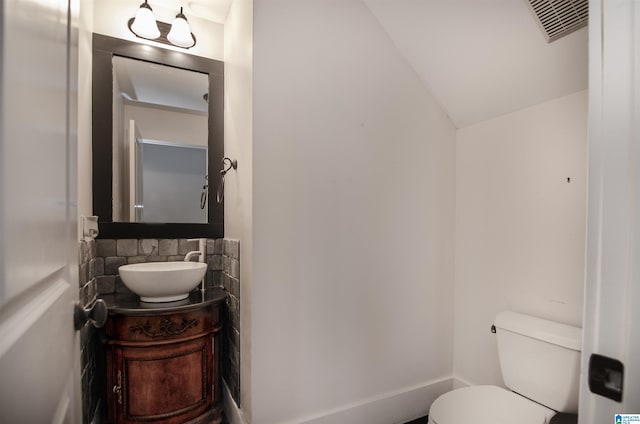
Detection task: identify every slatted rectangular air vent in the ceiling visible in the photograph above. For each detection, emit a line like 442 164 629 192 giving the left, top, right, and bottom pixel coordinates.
526 0 589 43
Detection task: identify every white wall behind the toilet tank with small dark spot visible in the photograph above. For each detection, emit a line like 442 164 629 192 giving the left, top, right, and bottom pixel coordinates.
454 91 587 385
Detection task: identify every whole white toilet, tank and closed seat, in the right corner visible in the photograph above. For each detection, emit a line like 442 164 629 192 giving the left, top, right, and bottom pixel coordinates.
429 311 582 424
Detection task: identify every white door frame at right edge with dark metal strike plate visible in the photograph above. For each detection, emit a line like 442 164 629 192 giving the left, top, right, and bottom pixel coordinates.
579 0 640 424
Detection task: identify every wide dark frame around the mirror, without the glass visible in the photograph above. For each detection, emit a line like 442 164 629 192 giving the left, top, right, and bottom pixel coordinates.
92 33 224 238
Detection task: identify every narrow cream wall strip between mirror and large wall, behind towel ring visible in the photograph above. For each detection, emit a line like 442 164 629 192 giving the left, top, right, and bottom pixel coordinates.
224 0 252 424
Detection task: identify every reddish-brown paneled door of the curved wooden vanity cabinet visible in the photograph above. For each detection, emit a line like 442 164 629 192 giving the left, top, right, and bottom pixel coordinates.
107 334 214 424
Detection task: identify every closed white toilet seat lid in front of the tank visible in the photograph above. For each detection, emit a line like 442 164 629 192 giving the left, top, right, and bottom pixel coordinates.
429 386 556 424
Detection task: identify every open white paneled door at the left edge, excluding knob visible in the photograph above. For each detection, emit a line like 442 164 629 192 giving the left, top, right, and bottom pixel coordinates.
0 0 81 423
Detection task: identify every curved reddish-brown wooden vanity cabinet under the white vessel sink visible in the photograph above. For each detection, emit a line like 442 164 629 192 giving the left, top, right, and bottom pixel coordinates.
105 292 222 424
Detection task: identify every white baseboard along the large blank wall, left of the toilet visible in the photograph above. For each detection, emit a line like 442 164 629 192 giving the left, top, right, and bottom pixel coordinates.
296 377 453 424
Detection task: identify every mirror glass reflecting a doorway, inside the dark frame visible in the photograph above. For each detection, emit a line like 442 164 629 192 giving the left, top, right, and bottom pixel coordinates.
112 56 209 223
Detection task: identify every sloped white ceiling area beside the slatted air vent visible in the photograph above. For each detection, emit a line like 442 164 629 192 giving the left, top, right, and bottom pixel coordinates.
363 0 587 128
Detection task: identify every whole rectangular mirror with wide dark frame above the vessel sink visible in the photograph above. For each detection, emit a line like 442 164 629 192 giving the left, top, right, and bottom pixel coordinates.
92 34 224 238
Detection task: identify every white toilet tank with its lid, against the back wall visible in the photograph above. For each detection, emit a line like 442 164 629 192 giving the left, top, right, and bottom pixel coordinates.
495 311 582 413
